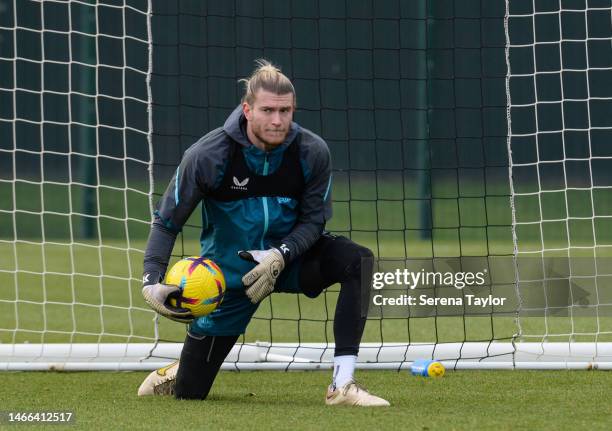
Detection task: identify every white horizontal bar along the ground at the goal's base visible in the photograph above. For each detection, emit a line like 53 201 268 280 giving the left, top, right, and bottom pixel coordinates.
0 342 612 371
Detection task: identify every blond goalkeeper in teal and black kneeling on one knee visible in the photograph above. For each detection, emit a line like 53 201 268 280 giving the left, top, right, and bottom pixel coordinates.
138 60 389 406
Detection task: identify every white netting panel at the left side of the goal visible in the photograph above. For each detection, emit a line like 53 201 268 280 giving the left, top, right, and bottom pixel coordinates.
0 1 154 343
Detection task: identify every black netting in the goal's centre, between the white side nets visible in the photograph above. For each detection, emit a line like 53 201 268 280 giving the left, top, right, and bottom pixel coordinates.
153 1 516 361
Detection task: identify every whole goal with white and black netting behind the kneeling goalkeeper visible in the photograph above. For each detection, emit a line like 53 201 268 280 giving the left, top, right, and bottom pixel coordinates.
0 0 612 370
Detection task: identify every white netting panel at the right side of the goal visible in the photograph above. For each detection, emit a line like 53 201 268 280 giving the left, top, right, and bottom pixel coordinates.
507 1 612 341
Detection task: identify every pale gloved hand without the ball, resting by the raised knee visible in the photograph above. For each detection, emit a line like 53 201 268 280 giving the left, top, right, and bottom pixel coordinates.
238 248 285 304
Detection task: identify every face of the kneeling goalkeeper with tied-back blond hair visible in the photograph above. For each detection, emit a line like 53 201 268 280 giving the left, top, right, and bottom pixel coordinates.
242 90 293 151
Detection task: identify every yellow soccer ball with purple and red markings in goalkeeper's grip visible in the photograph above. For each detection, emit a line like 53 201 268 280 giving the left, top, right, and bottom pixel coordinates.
165 256 225 317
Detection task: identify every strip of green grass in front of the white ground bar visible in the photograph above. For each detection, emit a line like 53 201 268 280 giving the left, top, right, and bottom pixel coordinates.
0 371 612 431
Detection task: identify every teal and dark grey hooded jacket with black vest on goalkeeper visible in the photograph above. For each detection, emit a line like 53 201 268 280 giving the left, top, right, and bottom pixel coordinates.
143 106 331 290
